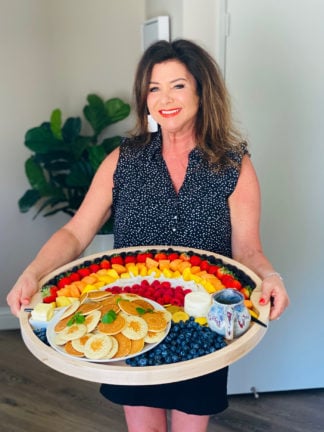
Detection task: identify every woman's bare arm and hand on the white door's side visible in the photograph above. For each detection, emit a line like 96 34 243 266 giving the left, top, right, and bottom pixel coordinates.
229 156 289 319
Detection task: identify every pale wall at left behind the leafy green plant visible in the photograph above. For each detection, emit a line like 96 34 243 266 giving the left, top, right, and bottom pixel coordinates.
0 0 145 310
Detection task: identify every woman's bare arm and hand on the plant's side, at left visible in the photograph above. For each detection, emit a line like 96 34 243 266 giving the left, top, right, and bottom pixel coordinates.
7 149 119 315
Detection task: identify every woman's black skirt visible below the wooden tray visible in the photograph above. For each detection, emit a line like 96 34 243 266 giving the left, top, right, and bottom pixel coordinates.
100 367 228 415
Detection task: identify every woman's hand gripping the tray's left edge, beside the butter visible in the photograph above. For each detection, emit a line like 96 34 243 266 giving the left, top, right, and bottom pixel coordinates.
7 270 38 316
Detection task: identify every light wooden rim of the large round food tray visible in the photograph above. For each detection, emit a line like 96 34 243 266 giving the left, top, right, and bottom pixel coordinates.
19 246 270 385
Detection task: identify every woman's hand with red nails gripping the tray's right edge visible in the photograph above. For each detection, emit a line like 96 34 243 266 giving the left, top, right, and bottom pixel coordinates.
259 273 289 320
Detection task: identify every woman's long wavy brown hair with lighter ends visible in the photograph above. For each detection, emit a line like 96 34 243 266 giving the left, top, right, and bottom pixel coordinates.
133 39 243 166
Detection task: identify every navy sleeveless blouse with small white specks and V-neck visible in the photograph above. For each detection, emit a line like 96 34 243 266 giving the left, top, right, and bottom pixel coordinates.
113 132 248 257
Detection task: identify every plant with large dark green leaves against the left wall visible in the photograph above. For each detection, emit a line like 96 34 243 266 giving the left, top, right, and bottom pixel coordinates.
18 94 130 234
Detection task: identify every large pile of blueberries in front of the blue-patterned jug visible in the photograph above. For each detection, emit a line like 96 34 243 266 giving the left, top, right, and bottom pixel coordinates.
126 317 226 366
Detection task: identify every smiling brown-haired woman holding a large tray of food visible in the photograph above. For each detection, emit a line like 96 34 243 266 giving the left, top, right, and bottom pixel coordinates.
8 40 289 432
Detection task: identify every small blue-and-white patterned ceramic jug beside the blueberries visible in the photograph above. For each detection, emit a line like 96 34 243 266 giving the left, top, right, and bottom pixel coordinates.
207 288 251 340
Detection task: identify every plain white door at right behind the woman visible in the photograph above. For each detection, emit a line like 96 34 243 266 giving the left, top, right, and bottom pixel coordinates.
221 0 324 394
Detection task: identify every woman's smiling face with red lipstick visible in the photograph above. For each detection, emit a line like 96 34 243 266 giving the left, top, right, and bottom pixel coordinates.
147 60 199 133
